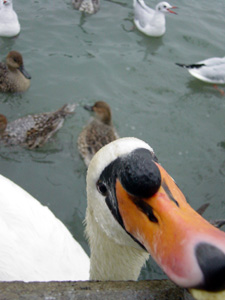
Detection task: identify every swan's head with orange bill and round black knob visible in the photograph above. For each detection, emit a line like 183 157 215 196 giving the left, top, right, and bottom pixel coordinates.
87 138 225 291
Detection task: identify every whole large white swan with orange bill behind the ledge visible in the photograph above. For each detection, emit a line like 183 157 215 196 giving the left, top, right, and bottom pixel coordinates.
0 137 225 300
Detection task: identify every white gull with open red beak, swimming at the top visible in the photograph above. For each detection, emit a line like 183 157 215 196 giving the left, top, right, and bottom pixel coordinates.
133 0 177 37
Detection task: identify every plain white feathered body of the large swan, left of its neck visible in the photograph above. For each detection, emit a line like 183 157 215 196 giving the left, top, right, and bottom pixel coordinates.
0 175 89 281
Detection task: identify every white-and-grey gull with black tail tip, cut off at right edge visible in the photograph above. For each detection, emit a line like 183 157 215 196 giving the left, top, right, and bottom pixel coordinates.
176 57 225 94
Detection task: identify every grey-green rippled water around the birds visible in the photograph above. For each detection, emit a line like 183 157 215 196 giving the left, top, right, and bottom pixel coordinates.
0 0 225 278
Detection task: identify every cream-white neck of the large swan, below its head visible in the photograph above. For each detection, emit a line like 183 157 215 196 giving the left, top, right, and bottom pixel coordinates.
86 207 149 280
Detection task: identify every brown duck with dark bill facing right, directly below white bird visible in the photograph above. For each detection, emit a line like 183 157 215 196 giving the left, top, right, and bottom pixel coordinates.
0 50 31 93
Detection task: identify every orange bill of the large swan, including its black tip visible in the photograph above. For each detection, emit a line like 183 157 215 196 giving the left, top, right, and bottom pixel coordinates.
116 163 225 290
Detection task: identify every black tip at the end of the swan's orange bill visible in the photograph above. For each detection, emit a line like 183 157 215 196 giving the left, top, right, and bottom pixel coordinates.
195 243 225 291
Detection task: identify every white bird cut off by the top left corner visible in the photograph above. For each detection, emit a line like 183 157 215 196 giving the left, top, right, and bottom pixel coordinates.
0 0 20 37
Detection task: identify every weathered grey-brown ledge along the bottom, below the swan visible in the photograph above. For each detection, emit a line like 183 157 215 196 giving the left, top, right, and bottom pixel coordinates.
0 280 193 300
